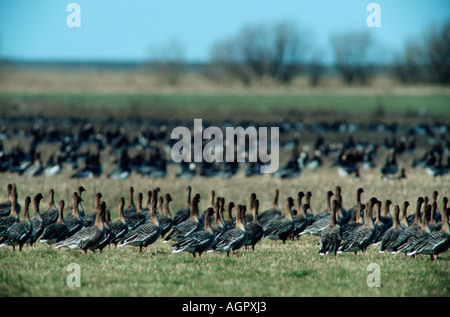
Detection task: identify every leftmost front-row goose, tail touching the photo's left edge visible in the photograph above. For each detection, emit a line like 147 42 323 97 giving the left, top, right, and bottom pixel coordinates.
0 196 33 251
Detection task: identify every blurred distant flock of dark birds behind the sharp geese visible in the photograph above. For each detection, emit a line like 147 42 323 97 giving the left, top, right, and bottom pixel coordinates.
0 117 450 180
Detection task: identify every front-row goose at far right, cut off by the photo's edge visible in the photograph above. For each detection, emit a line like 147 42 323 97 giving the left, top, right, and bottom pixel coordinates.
407 208 450 261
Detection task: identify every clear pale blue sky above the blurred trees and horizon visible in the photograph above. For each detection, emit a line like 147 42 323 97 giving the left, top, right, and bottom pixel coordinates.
0 0 450 61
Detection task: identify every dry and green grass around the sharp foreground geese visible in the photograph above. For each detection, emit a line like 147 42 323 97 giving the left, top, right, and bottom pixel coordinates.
0 168 450 297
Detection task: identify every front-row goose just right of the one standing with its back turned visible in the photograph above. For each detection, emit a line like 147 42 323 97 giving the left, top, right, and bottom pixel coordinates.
338 197 378 254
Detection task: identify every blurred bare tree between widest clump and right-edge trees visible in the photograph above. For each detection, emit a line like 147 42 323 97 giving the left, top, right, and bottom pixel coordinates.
331 31 373 85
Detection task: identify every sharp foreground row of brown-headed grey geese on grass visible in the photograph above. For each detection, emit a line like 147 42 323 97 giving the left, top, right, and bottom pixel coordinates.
0 184 450 261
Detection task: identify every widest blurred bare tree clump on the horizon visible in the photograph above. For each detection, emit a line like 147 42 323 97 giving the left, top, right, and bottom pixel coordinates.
211 22 308 85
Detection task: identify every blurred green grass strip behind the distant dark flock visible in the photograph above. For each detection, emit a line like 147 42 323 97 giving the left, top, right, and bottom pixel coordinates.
0 92 450 118
